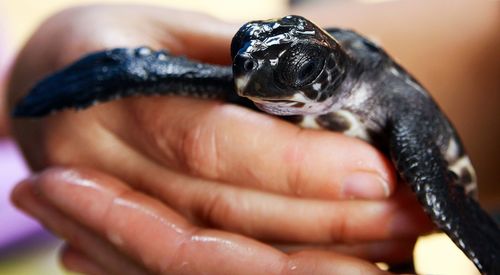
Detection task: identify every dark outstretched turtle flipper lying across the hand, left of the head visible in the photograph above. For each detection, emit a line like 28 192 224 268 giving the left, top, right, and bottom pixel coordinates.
13 47 235 117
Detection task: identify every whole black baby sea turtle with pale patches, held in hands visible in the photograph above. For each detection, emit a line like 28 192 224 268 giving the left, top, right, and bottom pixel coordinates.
14 16 500 274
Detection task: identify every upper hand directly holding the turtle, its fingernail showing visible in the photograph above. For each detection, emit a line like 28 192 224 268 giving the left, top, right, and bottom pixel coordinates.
9 6 430 274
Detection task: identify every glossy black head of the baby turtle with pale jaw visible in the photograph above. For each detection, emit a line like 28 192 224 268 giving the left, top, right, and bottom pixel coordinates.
231 15 348 115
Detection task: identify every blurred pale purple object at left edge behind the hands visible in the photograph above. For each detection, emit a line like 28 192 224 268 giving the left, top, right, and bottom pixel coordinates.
0 139 42 250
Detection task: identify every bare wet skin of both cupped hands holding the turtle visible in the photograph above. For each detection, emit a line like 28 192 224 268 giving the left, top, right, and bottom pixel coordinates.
5 6 431 274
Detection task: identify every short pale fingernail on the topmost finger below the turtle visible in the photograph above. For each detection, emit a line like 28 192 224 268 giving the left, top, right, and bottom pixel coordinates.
342 172 390 199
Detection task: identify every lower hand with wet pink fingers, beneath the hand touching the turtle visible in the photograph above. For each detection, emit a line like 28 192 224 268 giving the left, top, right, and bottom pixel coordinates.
13 168 402 275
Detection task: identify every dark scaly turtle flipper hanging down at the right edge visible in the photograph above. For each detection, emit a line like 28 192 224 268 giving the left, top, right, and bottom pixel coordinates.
390 117 500 274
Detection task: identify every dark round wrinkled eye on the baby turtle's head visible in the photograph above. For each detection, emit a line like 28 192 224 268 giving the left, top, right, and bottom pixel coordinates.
277 44 324 88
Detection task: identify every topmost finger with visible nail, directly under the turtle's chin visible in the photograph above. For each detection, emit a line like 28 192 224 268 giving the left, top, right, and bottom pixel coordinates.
99 98 396 199
